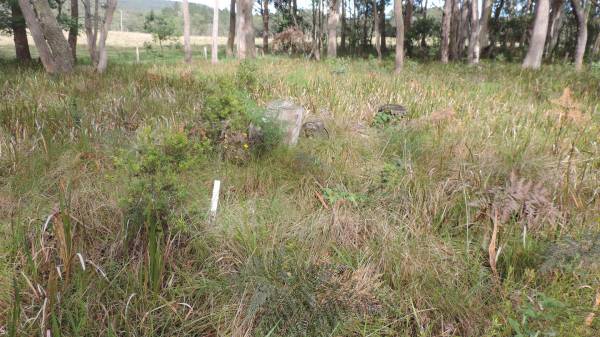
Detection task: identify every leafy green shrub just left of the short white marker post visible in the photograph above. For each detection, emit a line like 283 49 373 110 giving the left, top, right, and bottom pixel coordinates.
121 128 208 291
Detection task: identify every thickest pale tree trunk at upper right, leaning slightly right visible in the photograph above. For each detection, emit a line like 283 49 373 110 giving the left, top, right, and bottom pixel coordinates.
523 0 550 69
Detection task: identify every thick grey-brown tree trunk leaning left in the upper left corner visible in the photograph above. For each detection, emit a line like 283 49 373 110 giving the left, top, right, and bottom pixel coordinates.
19 0 73 74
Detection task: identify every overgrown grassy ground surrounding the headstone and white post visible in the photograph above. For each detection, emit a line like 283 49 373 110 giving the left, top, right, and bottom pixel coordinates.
0 45 600 336
